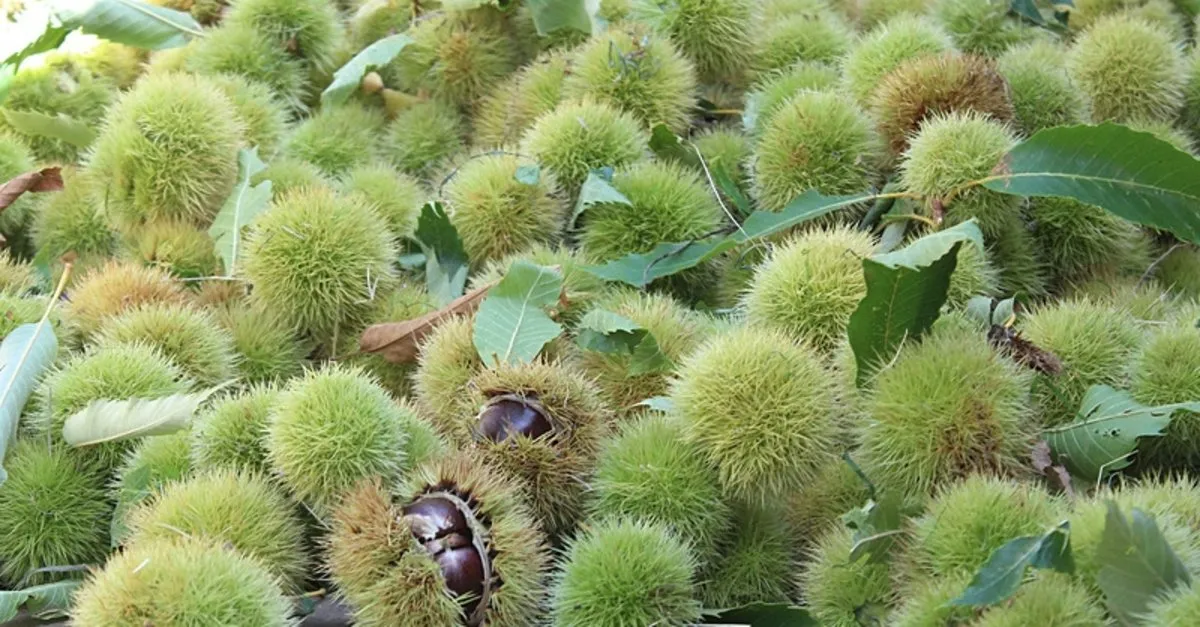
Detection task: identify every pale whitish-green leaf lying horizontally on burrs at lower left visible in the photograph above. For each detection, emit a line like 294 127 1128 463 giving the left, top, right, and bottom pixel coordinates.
62 383 228 447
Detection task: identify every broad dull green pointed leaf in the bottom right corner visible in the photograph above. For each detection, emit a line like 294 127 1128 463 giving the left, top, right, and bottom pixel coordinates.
1096 501 1192 625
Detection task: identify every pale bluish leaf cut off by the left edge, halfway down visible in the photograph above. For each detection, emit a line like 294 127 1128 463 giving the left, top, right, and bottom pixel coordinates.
0 317 59 484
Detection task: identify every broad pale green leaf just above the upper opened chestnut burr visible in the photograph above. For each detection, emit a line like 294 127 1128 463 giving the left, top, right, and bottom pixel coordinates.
474 261 563 365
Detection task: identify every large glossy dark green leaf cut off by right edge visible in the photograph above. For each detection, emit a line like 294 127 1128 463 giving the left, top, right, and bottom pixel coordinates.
982 124 1200 244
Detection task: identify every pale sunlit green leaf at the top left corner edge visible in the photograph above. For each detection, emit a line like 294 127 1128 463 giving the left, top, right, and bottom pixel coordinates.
58 0 204 50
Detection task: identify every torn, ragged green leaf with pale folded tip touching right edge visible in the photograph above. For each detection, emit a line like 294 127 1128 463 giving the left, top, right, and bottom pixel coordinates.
1044 386 1200 482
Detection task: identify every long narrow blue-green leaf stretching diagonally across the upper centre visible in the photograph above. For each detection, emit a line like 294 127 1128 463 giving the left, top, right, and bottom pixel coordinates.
583 190 874 287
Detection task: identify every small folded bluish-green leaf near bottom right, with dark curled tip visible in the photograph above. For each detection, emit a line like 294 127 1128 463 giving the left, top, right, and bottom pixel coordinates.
950 520 1075 607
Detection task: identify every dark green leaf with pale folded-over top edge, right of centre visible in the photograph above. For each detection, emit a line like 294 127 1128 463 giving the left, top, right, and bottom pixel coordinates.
847 220 983 384
